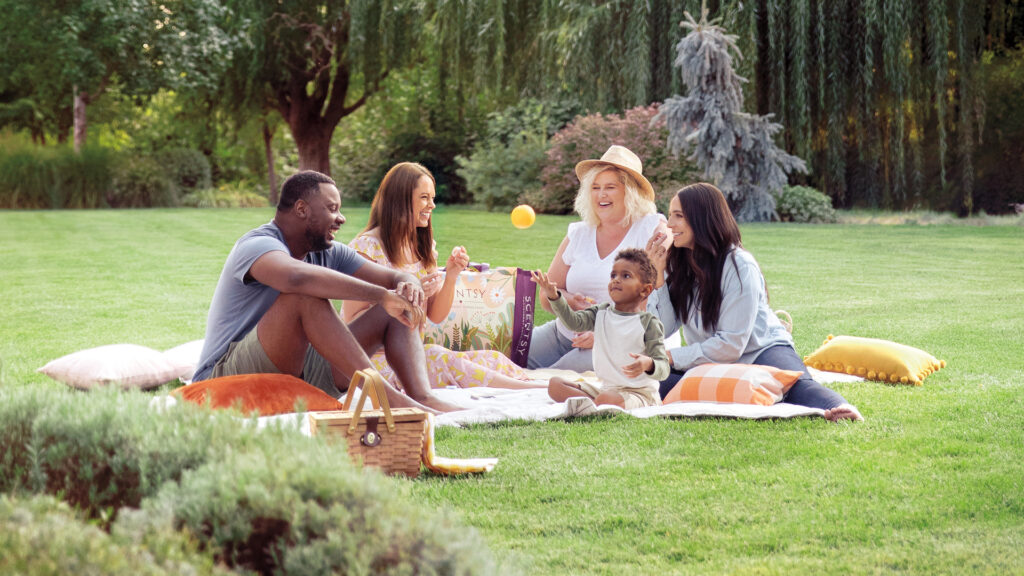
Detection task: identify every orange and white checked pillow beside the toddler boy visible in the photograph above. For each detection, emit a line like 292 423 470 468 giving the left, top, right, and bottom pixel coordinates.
662 364 803 406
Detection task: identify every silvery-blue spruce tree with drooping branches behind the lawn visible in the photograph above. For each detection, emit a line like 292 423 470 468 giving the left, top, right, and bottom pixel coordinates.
659 8 807 221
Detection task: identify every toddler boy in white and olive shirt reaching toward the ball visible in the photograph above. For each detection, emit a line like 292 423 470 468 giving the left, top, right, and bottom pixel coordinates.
531 248 669 416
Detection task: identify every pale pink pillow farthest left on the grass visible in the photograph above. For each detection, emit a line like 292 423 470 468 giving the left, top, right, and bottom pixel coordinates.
37 344 183 389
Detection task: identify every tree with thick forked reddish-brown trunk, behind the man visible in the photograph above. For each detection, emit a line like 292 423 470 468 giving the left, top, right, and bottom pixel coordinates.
223 0 423 173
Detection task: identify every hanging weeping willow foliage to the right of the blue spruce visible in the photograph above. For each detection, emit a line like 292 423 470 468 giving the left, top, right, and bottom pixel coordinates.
740 0 991 212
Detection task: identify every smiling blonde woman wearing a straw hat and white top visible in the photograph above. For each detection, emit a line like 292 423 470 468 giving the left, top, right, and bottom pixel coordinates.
527 145 665 372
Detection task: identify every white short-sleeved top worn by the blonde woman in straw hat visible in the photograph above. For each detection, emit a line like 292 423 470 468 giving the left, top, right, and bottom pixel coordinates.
557 213 665 339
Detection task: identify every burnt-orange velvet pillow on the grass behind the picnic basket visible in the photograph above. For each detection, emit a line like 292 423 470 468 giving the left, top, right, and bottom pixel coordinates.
172 374 341 416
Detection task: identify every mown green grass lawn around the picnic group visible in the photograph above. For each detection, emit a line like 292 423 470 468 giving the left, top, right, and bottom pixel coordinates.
0 204 1024 574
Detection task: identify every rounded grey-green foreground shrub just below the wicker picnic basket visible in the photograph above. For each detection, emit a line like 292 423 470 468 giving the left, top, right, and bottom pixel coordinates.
116 435 509 575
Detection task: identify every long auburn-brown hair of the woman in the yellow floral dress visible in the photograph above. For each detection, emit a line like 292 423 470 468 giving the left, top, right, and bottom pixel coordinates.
362 162 437 270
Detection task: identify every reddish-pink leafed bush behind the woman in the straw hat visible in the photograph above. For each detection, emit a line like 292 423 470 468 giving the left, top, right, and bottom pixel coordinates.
527 102 693 214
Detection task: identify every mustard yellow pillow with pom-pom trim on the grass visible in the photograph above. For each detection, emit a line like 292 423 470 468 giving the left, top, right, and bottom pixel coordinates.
804 334 946 386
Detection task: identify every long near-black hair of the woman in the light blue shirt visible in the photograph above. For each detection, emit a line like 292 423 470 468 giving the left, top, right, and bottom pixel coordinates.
667 182 742 332
